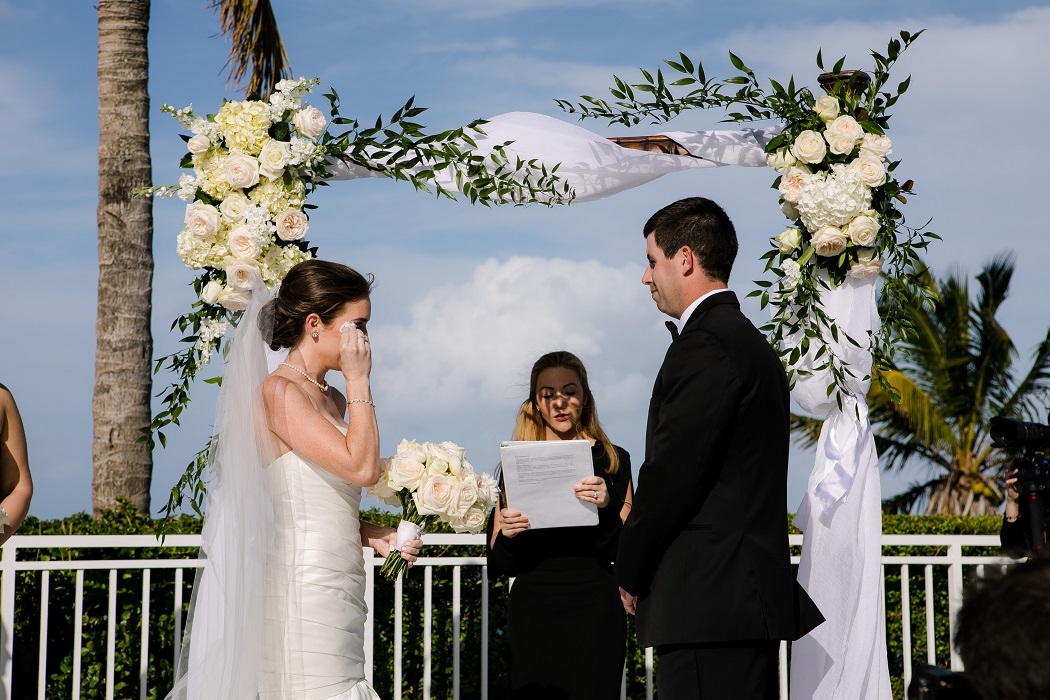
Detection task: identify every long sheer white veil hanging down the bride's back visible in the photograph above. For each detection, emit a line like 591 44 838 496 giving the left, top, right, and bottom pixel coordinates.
167 280 275 700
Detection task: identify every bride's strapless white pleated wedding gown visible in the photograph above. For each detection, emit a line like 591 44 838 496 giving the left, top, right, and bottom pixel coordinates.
259 452 379 700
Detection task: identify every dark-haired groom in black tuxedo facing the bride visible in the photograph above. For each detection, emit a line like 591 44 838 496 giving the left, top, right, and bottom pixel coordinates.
616 197 823 700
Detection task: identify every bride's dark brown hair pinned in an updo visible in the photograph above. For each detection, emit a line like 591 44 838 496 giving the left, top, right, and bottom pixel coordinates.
259 260 374 351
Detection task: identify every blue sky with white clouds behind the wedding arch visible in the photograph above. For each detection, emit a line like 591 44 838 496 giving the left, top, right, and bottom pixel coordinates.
0 0 1050 517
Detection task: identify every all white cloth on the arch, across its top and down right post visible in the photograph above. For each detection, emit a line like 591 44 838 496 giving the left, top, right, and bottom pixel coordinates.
331 112 890 700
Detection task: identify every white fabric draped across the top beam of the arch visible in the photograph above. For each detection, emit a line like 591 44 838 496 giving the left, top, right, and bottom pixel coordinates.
330 112 781 201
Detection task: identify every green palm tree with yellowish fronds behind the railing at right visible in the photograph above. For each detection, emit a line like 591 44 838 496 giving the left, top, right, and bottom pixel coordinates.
792 254 1050 515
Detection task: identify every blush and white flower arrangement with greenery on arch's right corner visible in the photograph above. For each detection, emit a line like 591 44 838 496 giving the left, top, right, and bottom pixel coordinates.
557 30 940 407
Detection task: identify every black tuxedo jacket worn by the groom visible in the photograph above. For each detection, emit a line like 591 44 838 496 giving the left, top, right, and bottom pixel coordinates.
616 292 823 646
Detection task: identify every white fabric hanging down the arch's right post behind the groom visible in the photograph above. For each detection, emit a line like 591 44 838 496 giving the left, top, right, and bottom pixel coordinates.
790 277 891 700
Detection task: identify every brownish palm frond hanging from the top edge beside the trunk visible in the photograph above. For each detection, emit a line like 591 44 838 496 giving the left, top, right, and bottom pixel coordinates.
211 0 292 98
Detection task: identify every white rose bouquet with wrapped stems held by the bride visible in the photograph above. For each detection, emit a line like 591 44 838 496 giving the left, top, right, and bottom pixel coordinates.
369 440 500 580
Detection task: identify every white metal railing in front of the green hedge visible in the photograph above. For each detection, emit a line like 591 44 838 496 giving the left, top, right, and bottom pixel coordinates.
0 534 1007 700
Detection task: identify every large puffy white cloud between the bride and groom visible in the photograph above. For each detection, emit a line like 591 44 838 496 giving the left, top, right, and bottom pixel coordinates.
373 257 658 422
